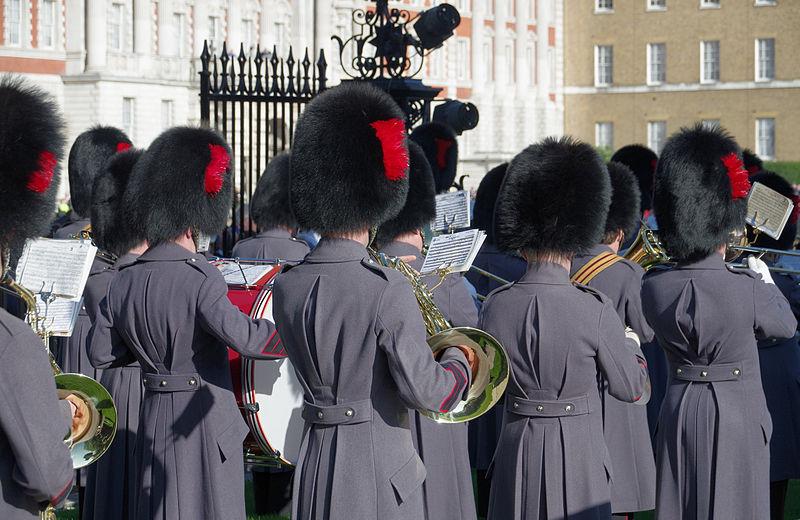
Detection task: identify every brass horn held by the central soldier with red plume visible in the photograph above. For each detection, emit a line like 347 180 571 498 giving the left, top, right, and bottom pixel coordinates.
370 249 509 423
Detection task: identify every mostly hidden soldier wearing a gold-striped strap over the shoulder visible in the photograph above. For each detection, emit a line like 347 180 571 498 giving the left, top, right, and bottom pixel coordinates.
570 162 656 519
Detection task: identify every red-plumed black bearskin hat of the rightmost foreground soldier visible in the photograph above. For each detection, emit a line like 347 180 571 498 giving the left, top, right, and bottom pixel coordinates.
653 124 750 261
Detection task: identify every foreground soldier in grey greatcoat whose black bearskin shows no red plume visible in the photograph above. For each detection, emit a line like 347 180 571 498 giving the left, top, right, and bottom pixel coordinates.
479 137 647 520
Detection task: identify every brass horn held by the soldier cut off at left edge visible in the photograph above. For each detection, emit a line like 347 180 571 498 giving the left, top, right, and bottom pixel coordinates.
2 275 117 469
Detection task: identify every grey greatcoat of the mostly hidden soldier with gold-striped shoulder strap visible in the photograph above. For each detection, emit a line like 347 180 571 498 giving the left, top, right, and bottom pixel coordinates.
571 244 656 513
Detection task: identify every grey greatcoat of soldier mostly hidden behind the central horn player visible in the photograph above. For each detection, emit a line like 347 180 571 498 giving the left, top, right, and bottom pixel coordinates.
381 242 478 520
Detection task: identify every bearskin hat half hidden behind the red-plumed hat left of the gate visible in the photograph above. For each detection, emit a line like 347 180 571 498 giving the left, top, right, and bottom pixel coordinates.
91 149 144 256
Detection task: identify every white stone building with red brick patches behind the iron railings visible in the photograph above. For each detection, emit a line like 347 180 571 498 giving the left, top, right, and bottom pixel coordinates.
0 0 563 200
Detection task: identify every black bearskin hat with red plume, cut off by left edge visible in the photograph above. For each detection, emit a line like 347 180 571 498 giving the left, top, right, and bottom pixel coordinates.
0 75 64 254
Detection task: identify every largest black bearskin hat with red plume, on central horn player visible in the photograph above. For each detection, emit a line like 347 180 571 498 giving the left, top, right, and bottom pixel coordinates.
290 81 408 235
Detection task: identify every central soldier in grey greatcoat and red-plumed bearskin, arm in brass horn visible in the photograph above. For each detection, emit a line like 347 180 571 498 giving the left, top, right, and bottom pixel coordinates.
273 82 475 520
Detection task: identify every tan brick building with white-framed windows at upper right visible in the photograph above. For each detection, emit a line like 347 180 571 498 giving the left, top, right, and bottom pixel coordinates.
564 0 800 161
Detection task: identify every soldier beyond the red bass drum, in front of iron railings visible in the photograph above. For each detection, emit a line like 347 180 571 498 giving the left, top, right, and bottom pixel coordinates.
233 152 310 263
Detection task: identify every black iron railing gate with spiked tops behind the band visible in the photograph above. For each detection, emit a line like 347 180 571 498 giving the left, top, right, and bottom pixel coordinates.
200 42 328 255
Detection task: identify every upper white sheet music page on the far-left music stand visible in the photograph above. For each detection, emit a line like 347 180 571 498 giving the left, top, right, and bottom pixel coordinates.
17 238 97 298
